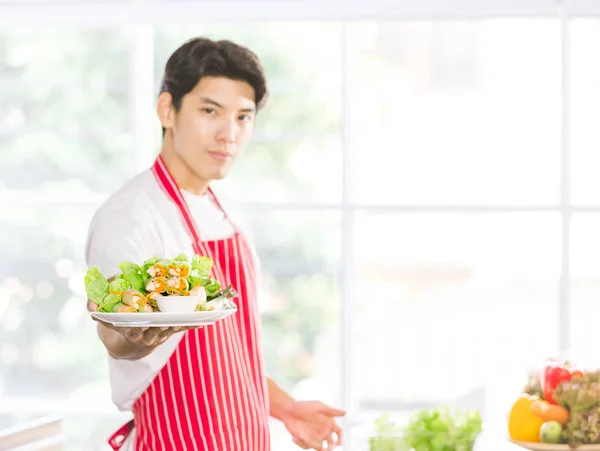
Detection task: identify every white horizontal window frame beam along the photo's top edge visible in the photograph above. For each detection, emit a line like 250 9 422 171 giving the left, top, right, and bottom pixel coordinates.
0 0 564 26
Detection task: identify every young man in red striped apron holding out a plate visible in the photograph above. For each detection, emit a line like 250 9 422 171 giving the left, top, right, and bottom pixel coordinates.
86 39 344 451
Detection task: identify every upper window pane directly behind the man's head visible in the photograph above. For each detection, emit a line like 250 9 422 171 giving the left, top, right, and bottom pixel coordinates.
155 22 342 202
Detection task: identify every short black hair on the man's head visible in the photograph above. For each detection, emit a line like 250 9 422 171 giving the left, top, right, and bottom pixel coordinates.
160 37 268 136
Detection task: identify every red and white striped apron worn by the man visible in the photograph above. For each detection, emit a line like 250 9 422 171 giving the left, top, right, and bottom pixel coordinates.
109 157 270 451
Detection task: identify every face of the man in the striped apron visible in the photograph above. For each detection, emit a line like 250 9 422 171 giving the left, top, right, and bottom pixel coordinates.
165 77 256 181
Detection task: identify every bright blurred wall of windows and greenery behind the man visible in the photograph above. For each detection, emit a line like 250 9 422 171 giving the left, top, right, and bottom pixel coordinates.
0 0 600 451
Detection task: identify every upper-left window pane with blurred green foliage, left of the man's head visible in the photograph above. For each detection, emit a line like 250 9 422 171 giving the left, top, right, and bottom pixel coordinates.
0 27 133 194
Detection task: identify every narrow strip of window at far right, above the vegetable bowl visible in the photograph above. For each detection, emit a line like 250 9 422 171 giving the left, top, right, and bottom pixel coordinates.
569 19 600 370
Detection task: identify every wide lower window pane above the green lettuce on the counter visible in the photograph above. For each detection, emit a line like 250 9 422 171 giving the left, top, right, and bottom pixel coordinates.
353 212 560 412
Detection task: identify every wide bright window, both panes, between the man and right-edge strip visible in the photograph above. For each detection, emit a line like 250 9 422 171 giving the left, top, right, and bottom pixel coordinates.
347 19 561 410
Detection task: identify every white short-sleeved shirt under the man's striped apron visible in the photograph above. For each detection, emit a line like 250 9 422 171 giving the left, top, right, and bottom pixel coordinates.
86 170 257 410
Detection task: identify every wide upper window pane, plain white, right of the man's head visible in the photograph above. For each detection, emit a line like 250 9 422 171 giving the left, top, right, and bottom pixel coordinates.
348 19 561 204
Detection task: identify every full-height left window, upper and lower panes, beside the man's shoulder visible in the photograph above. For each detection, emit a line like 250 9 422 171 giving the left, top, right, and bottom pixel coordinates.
0 27 135 449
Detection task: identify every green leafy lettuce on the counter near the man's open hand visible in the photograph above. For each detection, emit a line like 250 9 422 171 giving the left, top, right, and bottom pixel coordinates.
369 406 483 451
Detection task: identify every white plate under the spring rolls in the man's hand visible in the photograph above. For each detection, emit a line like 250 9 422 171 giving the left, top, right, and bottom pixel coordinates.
90 309 237 327
